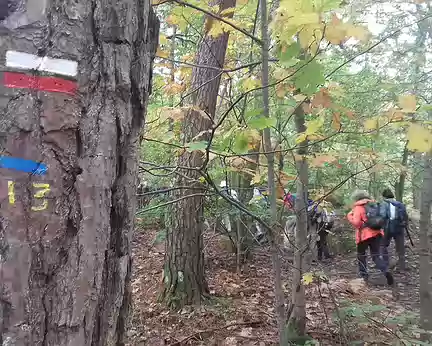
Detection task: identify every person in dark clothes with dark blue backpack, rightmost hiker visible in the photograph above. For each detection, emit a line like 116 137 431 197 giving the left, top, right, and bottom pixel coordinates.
381 189 408 270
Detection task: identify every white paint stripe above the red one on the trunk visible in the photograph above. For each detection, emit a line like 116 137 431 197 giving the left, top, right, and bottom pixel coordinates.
6 51 78 77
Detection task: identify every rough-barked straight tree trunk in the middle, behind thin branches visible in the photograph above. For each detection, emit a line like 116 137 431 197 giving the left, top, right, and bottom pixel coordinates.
160 0 235 308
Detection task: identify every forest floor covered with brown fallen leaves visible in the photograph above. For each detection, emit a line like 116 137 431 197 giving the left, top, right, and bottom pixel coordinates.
125 220 419 346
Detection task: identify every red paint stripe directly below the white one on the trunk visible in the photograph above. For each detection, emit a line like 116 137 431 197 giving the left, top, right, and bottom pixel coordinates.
3 72 77 95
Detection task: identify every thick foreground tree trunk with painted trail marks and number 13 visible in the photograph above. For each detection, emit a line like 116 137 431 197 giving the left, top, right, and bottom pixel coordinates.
0 0 159 346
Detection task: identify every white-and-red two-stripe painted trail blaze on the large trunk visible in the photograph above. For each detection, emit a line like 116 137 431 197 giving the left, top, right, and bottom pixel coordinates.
3 51 78 95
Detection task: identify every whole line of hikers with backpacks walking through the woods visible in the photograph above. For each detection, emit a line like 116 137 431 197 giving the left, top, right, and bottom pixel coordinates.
220 181 409 286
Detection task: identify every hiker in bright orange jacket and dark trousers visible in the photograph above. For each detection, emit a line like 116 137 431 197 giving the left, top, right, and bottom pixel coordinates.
347 190 394 286
